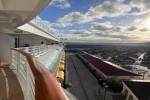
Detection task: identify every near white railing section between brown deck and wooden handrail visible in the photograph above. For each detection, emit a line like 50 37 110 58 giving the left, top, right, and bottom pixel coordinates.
11 50 35 100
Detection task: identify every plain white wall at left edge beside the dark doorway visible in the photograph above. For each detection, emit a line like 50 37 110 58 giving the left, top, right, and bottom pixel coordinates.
0 33 15 61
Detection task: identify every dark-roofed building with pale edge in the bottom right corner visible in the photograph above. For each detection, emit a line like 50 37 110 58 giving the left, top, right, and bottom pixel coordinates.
122 80 150 100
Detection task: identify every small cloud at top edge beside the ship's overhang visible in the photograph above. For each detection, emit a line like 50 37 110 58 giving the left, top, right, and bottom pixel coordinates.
49 0 71 9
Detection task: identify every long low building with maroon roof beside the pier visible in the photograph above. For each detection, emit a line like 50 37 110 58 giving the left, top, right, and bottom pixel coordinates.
80 53 141 80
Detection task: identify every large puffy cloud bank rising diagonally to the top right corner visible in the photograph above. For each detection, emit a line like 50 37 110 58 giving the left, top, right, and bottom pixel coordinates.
57 0 150 27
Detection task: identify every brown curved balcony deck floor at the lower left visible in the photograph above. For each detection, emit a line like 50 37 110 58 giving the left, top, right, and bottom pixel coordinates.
0 65 24 100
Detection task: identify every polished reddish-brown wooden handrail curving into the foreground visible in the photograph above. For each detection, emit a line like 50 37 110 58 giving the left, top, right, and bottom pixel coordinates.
12 49 68 100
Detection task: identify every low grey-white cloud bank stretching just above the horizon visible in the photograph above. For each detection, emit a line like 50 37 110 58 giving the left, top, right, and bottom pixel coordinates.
64 22 149 42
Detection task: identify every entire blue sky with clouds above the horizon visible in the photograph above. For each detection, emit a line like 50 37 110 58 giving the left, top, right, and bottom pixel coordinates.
38 0 150 43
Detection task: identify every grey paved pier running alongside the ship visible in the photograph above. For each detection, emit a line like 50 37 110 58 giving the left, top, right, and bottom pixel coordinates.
66 53 112 100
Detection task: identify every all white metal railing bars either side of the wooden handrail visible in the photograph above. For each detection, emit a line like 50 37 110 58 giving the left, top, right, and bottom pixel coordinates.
11 45 60 100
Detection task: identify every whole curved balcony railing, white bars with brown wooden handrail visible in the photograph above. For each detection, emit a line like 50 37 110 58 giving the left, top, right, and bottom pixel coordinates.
11 45 76 100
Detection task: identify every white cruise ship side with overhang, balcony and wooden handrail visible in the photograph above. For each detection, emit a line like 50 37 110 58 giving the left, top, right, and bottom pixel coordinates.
0 0 76 100
